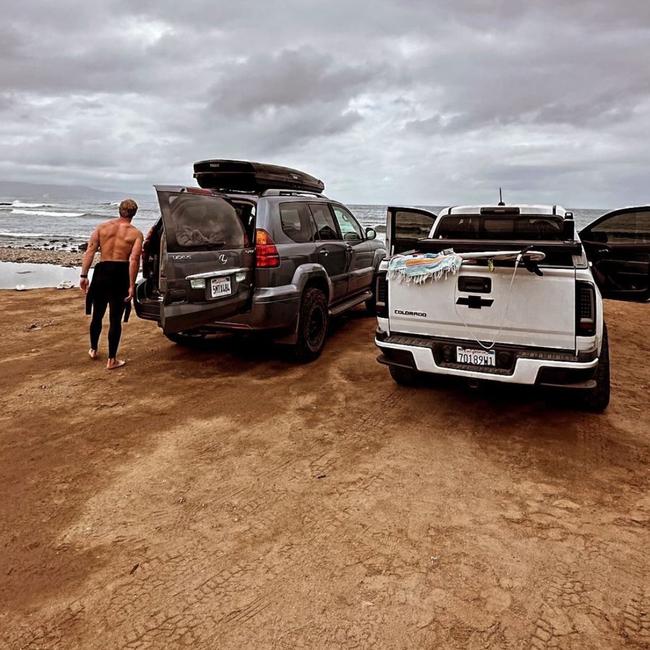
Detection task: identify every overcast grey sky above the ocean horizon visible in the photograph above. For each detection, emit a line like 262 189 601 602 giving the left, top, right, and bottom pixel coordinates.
0 0 650 207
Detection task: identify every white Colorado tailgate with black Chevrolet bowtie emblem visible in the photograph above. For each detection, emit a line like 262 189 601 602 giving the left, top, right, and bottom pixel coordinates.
388 264 575 350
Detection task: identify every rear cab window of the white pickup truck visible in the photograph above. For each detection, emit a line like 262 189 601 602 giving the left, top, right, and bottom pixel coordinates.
435 214 564 241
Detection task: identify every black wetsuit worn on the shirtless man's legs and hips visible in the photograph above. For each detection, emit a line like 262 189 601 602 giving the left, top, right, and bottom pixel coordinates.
87 262 130 359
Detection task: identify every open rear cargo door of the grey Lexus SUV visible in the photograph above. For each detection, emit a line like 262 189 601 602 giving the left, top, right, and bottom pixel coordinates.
156 187 255 334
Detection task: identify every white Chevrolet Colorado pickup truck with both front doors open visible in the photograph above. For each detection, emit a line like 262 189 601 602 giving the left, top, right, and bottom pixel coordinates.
375 204 650 411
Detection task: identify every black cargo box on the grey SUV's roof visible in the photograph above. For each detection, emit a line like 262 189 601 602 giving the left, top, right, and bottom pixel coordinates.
194 160 325 194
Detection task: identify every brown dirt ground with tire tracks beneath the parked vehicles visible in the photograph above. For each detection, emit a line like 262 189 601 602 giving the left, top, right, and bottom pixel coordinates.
0 290 650 649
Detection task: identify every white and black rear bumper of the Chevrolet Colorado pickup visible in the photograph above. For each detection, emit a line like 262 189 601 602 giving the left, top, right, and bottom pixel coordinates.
375 333 598 388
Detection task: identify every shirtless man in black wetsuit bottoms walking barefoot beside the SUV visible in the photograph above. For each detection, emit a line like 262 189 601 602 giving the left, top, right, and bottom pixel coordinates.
79 199 142 370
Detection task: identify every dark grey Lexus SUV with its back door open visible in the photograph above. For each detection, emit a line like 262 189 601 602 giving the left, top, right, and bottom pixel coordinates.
135 165 386 361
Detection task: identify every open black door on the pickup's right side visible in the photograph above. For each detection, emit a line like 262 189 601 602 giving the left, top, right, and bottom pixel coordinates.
580 206 650 301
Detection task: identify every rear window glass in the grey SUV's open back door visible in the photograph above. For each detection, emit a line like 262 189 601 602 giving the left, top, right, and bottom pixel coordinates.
159 192 254 251
